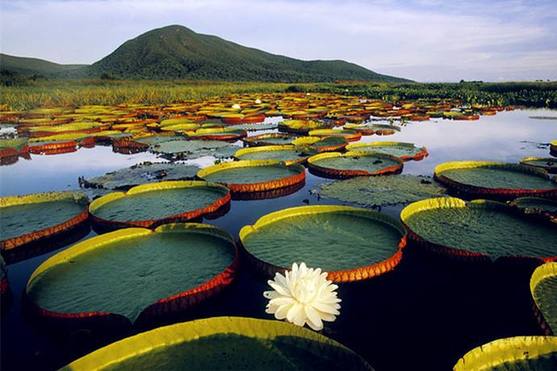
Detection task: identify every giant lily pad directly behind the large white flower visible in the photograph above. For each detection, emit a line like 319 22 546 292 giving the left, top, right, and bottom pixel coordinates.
240 205 405 282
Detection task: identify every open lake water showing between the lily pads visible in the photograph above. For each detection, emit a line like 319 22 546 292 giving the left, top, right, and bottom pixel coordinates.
0 110 557 370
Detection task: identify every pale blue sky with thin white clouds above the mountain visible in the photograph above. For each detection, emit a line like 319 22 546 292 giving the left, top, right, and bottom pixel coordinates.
0 0 557 81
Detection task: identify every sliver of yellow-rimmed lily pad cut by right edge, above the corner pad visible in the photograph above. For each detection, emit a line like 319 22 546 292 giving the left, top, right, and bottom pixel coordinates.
530 263 557 334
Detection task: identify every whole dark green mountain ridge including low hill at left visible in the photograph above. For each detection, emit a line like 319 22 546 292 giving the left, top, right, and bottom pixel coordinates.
0 25 409 82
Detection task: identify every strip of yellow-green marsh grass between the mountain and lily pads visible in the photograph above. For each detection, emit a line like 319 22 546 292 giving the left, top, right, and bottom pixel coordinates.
0 77 557 110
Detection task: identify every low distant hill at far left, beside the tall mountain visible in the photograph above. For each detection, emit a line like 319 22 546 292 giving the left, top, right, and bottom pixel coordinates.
0 53 88 77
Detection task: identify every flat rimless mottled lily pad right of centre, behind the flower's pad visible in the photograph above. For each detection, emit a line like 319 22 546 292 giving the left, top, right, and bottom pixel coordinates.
315 175 445 207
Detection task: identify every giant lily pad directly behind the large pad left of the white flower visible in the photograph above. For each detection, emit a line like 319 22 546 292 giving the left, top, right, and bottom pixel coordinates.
89 181 230 227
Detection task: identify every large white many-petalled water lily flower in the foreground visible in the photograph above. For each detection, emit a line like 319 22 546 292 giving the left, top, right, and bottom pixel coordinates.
263 263 341 331
